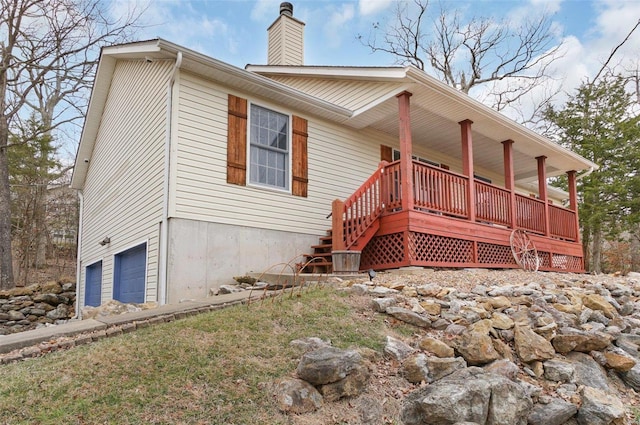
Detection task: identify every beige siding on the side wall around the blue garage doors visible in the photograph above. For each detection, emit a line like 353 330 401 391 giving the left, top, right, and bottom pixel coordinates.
78 61 173 303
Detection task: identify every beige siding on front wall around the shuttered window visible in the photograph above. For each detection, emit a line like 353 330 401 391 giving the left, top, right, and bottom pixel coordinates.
172 73 391 234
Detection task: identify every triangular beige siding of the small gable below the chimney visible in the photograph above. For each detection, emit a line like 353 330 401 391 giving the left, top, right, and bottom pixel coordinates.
264 76 400 111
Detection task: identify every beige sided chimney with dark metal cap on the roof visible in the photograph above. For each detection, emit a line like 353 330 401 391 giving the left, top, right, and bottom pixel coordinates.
267 2 304 65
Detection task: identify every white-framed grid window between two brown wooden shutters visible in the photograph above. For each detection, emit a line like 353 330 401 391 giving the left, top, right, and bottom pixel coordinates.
249 105 289 190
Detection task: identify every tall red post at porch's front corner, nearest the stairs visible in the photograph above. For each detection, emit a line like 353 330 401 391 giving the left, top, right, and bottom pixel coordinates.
396 91 414 211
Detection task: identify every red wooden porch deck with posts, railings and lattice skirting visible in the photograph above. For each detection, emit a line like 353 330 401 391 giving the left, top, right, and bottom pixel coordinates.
331 91 584 272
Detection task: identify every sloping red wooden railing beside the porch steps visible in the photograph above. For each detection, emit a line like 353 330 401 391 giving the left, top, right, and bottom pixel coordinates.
331 161 389 251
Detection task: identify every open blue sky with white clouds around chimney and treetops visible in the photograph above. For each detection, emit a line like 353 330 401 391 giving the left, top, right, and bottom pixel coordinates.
113 0 640 85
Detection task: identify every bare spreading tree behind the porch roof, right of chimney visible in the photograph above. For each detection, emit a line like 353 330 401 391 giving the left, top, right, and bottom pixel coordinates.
359 0 561 119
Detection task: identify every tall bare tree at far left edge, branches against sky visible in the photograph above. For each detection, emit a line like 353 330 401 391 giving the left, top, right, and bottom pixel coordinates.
0 0 139 289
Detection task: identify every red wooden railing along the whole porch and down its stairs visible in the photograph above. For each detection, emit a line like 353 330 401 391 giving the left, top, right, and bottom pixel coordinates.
332 161 578 249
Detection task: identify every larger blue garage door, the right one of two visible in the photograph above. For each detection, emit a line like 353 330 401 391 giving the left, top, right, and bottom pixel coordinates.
113 244 147 303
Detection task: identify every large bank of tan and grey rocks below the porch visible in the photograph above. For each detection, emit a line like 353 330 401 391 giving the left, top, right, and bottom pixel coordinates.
276 270 640 425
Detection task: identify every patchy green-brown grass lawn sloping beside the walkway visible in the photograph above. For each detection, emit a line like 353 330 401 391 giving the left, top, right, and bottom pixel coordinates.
0 289 385 424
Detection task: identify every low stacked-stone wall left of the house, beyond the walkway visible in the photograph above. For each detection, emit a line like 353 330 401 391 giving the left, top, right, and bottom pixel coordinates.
0 282 76 335
